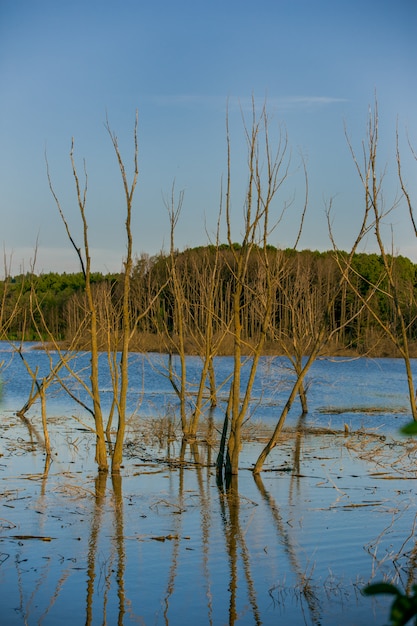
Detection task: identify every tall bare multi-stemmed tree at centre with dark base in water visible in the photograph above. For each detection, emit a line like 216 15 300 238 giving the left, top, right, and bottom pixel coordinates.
217 100 302 478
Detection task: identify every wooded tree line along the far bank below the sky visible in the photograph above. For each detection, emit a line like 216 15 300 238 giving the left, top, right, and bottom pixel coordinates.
0 244 417 357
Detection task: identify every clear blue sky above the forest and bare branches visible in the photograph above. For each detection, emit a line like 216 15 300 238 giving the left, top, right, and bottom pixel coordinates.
0 0 417 273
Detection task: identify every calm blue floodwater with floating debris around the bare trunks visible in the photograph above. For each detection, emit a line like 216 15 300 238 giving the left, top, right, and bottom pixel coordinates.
0 345 417 626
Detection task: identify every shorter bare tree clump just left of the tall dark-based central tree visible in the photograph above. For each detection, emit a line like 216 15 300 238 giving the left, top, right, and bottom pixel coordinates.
157 185 226 441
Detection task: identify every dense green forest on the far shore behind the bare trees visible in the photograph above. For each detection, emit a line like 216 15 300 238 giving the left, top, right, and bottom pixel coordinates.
0 244 417 355
